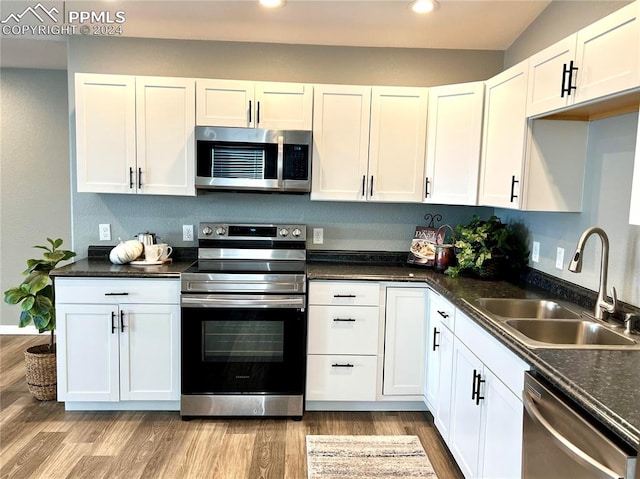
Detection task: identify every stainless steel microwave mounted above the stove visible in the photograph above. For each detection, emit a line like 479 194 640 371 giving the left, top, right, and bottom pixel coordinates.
196 126 312 193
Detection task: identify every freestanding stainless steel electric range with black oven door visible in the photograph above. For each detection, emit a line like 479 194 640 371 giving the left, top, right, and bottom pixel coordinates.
180 223 307 419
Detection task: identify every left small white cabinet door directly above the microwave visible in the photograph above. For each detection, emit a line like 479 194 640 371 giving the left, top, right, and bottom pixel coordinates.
196 80 256 128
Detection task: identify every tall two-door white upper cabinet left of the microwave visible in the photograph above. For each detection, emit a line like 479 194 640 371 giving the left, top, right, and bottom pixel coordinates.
75 73 195 196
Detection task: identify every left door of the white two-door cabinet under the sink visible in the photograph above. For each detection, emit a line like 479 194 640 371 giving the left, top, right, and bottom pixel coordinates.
449 339 484 478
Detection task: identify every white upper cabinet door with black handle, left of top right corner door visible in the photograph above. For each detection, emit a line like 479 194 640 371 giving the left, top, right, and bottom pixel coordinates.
527 34 576 116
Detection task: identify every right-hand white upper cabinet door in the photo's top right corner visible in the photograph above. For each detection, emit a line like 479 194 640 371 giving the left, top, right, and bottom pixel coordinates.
574 2 640 103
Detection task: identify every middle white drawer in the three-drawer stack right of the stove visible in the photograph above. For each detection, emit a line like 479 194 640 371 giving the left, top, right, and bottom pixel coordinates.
308 305 378 354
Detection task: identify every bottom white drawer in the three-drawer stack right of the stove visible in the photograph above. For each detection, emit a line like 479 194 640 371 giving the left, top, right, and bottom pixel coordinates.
306 354 378 401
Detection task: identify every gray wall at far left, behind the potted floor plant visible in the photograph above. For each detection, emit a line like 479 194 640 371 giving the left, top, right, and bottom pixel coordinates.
0 69 71 324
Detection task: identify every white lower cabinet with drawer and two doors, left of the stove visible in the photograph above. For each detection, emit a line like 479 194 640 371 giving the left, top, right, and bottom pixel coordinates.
55 278 180 405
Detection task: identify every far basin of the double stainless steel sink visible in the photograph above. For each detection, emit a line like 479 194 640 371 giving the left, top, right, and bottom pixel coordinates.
477 298 580 319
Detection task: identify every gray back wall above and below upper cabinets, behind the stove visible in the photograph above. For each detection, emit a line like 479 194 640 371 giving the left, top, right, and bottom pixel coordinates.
68 37 503 258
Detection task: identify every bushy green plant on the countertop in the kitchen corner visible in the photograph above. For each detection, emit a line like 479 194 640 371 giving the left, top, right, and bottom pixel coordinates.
445 215 529 279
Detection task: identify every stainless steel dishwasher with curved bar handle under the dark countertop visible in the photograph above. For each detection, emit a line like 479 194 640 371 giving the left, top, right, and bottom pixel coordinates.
522 373 640 479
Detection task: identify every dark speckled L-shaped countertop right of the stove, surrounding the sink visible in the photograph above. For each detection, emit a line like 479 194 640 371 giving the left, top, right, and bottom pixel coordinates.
308 261 640 450
